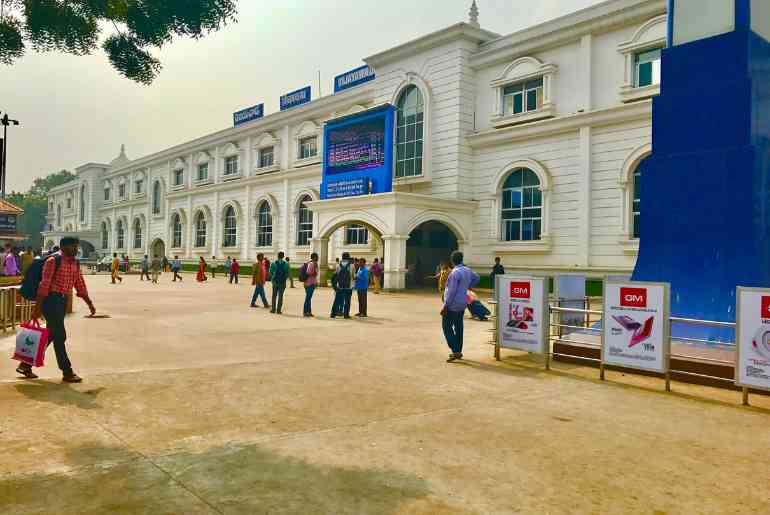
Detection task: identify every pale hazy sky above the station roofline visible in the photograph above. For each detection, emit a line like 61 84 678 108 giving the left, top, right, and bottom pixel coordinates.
0 0 600 191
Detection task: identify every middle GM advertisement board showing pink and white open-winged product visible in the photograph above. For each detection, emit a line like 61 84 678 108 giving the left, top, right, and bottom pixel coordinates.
602 281 670 373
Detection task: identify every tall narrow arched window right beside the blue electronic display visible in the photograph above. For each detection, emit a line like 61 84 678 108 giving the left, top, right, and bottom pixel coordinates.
396 86 425 178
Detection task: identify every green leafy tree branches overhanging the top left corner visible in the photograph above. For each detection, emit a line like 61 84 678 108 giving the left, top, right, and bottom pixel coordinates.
0 0 236 84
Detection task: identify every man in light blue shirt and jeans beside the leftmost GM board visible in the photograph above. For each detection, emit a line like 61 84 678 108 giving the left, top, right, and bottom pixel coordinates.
441 250 479 363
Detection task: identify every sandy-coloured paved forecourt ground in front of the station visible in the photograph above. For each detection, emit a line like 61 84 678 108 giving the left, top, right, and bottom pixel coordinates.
0 276 770 515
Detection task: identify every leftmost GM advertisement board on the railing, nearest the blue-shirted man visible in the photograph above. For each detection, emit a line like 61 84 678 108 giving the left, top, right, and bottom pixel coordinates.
495 275 549 354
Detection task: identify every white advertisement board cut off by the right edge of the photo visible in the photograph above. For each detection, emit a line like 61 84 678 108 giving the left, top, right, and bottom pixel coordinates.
735 287 770 390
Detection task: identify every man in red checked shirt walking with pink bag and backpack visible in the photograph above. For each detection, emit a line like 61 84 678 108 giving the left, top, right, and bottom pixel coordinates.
16 237 96 383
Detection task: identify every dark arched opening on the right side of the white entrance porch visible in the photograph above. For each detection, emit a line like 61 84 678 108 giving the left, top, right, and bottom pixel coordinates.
406 220 459 288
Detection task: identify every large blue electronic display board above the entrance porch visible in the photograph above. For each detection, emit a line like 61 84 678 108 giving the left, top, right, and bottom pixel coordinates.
321 104 395 199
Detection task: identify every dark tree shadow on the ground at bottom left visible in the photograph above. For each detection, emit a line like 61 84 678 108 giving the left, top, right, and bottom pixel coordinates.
0 445 463 515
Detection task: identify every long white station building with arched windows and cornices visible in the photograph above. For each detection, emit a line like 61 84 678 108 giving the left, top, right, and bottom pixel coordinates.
44 0 667 289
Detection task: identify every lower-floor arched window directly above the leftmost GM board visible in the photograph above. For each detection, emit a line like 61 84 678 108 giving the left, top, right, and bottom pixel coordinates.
500 168 543 241
